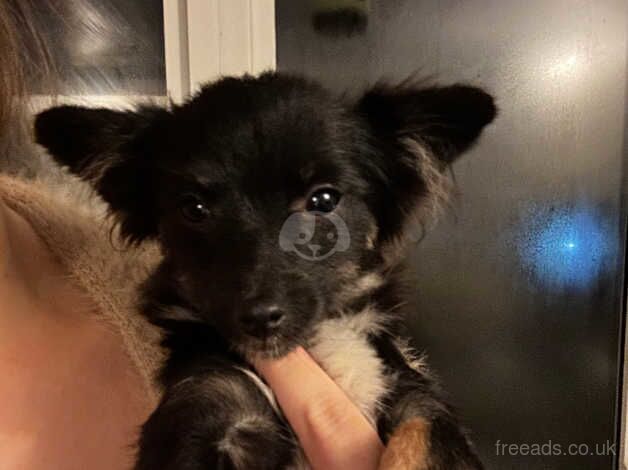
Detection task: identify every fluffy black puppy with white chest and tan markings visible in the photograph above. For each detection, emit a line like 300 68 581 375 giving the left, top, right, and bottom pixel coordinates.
35 73 496 470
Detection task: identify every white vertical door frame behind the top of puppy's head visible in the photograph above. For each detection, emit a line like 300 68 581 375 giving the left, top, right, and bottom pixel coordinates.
163 0 276 102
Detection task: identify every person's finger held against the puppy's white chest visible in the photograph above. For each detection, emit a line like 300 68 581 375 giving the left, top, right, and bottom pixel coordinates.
255 347 383 470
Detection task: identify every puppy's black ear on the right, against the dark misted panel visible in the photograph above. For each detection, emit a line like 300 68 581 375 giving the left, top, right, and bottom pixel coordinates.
357 85 497 248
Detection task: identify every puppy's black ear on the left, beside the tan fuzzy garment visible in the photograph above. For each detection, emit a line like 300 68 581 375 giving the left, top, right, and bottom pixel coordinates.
35 106 169 242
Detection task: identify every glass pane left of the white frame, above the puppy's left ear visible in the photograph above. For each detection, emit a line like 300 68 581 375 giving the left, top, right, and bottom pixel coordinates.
24 0 166 95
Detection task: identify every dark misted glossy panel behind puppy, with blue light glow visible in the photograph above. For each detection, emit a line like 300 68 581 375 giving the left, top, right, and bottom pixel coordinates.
277 0 628 470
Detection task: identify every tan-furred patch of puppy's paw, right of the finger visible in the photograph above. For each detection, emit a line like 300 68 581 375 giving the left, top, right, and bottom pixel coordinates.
379 418 431 470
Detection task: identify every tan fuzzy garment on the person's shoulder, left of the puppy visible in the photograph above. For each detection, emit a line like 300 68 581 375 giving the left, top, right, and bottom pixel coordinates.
0 174 164 402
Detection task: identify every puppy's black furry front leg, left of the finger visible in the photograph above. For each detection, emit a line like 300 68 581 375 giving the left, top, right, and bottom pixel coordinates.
135 368 296 470
